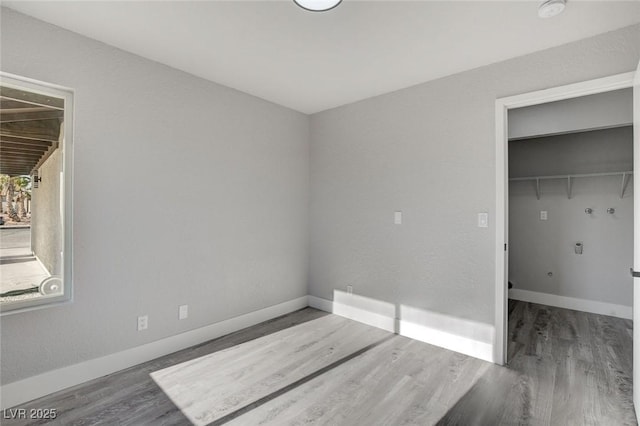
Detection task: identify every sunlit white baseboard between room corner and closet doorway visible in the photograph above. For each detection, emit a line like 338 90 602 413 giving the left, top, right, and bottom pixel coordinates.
309 292 495 362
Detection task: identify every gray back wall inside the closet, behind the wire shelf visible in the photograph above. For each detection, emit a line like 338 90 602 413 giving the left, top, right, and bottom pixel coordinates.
509 127 633 306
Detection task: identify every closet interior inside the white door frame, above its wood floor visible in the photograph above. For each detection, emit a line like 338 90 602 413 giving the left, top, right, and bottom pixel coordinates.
508 88 633 316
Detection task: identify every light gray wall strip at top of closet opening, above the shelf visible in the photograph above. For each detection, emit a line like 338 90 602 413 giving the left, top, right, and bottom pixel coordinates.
509 88 633 139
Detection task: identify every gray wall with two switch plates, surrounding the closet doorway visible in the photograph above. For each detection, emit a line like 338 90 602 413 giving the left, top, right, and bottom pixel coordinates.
309 25 640 330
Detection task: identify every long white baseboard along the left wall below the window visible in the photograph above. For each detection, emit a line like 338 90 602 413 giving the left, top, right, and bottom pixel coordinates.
0 296 309 409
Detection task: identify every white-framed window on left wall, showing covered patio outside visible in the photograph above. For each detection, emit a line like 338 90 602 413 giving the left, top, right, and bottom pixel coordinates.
0 72 73 315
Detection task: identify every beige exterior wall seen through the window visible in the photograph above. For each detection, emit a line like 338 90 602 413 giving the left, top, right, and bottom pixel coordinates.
31 149 62 276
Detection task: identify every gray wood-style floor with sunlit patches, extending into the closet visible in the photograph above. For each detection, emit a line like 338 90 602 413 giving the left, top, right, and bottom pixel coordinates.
2 302 637 426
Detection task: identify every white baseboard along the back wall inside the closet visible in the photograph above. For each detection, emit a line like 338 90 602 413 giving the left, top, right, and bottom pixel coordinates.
509 288 633 319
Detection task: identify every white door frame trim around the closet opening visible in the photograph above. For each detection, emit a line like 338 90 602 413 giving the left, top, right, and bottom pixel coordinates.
493 71 640 365
